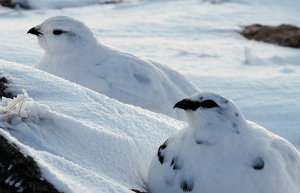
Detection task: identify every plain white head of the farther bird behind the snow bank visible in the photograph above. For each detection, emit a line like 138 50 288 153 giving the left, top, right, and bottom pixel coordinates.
27 16 97 54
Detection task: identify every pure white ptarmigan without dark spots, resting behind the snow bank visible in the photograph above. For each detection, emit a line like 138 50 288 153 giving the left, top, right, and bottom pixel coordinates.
28 16 198 120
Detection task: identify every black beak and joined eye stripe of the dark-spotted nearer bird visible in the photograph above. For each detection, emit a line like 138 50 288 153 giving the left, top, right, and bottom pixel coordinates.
174 99 220 111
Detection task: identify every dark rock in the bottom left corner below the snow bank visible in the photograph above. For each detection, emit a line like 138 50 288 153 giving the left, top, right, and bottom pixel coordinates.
0 135 60 193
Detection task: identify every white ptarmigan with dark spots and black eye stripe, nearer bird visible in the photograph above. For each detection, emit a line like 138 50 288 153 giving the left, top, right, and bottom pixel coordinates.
148 93 300 193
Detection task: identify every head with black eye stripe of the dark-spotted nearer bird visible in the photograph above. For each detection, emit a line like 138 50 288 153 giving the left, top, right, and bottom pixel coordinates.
174 92 244 127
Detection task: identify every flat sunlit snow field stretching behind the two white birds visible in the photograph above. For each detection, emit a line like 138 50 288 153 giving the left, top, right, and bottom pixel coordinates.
0 0 300 148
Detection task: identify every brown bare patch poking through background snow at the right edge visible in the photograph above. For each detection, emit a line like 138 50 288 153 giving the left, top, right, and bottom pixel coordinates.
241 24 300 48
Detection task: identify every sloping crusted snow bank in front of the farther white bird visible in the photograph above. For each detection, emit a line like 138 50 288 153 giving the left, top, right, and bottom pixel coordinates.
0 61 183 193
